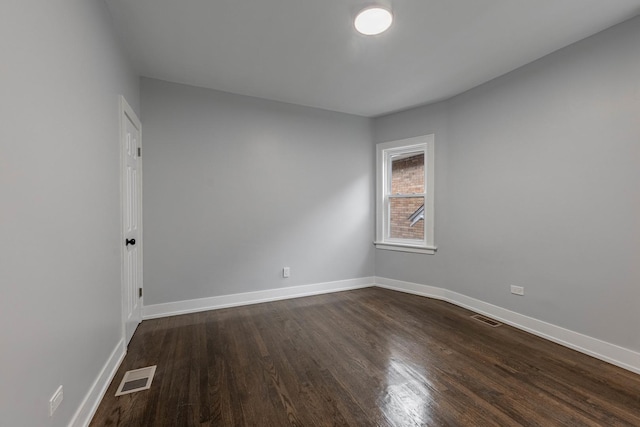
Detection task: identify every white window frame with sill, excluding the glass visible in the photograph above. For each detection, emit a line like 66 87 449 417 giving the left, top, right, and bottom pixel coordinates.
374 134 437 255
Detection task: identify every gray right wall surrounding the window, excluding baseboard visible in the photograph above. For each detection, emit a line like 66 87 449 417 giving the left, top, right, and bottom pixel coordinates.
374 18 640 351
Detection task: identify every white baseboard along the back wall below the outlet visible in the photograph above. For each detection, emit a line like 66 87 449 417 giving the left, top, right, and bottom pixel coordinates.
142 277 374 320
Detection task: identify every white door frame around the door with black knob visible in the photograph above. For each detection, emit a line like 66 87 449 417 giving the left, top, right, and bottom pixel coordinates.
118 95 144 351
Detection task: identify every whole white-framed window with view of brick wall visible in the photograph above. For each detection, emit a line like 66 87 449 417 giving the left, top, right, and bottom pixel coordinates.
375 135 436 254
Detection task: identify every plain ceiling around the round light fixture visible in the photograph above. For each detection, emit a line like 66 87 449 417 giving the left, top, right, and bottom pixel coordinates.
105 0 640 117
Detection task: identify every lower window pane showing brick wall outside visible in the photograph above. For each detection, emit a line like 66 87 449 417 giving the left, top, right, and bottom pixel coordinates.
389 197 424 240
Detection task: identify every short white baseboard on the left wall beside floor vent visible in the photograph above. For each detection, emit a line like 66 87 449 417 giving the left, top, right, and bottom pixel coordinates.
69 339 127 427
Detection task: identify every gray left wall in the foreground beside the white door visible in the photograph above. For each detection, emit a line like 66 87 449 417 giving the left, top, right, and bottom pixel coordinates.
0 0 139 426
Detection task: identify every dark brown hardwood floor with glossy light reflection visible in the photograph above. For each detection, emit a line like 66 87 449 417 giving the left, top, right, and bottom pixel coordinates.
91 288 640 426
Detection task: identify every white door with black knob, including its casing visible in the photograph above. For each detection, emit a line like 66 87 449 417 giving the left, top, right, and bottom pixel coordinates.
120 97 142 345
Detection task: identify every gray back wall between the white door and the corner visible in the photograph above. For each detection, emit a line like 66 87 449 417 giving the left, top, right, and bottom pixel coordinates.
141 78 374 305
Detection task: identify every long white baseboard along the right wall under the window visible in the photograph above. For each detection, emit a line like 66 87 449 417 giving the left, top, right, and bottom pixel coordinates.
375 277 640 374
